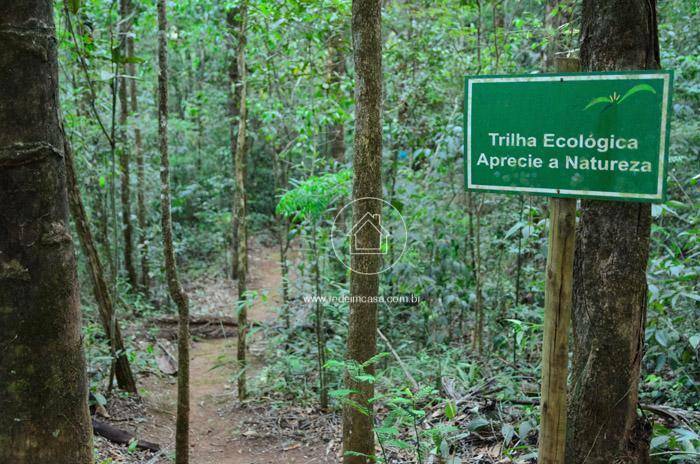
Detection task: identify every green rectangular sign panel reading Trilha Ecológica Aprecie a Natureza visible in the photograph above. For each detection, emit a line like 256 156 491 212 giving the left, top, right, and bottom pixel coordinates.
464 71 673 202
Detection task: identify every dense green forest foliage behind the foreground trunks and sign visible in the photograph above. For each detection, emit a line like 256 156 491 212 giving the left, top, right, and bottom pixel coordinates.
23 0 700 463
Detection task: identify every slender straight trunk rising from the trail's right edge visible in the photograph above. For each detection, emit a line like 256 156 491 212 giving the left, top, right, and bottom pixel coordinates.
234 0 248 400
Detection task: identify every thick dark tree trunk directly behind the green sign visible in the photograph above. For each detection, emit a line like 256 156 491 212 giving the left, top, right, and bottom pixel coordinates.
566 0 659 464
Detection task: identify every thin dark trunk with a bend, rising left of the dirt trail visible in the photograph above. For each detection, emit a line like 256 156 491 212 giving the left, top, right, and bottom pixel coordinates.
158 0 190 464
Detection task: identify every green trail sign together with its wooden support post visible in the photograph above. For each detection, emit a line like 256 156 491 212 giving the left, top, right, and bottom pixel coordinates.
464 59 673 464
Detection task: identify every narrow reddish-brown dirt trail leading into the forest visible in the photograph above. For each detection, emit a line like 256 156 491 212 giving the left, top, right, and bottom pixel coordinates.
141 247 335 464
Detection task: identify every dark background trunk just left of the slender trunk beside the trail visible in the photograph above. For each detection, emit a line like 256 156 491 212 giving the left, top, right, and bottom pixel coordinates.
226 8 241 279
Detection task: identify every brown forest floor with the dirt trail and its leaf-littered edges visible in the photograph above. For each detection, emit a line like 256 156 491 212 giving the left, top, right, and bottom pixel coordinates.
96 247 339 464
